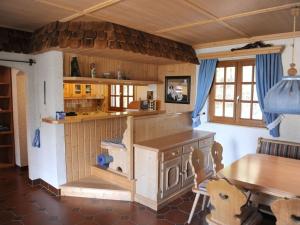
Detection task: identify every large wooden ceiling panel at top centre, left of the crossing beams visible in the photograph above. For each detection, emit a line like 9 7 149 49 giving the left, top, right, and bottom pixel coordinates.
92 0 208 32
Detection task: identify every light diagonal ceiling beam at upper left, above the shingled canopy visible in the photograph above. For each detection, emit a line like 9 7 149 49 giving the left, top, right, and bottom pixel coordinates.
59 0 122 22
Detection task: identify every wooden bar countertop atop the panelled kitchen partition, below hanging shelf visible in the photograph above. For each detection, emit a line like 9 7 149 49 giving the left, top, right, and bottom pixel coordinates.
42 110 166 124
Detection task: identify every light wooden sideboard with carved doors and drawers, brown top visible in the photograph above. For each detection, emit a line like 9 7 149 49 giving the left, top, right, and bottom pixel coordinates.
134 130 214 210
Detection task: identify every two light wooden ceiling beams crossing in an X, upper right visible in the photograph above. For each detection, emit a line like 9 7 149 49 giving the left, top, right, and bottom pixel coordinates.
155 0 300 37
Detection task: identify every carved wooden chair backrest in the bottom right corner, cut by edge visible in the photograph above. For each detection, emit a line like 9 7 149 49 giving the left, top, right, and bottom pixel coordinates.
271 199 300 225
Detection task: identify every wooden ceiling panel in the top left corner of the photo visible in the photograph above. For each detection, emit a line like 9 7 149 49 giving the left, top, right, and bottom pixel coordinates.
0 0 73 31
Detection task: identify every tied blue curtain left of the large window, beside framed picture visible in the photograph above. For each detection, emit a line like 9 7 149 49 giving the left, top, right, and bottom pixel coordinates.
192 59 218 128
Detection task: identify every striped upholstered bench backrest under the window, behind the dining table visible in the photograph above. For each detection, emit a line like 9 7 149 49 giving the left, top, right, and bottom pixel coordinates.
256 138 300 159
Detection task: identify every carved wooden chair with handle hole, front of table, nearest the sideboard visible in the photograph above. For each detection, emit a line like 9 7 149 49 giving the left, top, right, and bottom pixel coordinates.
206 179 262 225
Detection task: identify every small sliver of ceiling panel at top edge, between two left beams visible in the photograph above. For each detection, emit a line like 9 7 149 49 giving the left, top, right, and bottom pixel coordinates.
41 0 107 10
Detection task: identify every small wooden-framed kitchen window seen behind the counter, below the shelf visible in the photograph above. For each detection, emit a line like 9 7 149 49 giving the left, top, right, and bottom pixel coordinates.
108 84 134 111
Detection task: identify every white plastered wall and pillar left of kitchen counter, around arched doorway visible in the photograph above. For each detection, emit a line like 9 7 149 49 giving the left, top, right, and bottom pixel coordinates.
0 51 66 188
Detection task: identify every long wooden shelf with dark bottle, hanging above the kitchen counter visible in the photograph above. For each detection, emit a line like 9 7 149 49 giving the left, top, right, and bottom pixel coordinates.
64 76 162 86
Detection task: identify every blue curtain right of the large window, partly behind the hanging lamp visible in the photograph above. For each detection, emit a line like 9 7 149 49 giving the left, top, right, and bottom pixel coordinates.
256 53 283 137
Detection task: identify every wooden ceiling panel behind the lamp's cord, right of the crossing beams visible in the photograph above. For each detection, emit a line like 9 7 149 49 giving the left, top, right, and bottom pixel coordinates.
226 10 300 36
